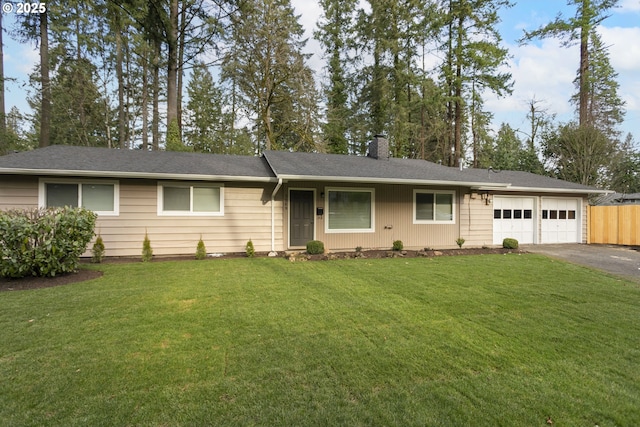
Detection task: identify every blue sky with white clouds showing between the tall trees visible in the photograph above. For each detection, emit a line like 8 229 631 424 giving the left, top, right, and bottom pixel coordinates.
0 0 640 148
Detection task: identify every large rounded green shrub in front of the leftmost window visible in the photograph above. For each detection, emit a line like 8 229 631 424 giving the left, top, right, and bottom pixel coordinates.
0 207 97 278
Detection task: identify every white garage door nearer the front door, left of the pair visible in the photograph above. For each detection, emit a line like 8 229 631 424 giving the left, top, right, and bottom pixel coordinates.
493 196 535 245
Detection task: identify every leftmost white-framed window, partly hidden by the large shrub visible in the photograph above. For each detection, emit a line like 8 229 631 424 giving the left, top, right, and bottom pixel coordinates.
39 180 119 215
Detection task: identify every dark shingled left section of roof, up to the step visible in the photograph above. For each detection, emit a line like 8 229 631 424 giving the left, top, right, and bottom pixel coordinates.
0 145 274 179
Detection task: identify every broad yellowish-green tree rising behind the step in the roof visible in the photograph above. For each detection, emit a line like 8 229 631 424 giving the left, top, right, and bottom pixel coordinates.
223 0 317 151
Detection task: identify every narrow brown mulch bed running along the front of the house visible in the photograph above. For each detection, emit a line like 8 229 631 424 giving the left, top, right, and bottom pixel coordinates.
0 248 524 292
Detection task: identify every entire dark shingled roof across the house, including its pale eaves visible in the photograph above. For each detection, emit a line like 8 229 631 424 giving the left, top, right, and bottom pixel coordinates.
0 145 604 194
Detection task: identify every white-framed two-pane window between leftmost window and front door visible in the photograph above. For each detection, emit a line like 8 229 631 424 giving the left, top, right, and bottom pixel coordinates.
158 183 224 216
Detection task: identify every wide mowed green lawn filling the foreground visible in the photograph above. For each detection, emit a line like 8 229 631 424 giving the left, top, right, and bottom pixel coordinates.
0 254 640 427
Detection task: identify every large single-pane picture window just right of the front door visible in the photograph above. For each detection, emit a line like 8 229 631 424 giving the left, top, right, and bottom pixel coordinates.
325 188 374 233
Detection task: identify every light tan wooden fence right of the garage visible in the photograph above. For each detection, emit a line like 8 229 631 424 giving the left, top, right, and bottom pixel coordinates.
587 205 640 246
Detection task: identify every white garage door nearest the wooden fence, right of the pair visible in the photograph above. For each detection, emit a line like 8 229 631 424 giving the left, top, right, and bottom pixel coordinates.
541 198 582 243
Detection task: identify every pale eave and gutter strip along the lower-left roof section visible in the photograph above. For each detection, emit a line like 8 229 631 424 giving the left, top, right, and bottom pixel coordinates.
0 168 278 182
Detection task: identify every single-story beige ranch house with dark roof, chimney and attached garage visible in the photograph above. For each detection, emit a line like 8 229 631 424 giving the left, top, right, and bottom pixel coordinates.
0 137 606 256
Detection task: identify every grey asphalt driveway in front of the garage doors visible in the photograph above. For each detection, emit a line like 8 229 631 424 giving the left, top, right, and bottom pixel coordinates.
521 244 640 283
